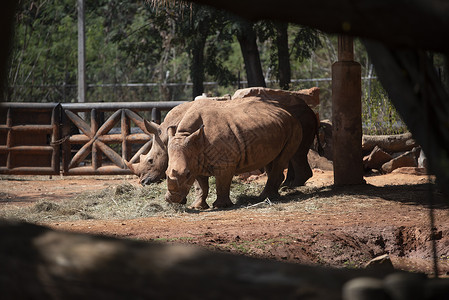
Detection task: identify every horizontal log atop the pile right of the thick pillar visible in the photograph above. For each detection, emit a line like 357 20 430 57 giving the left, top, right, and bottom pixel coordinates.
362 132 418 153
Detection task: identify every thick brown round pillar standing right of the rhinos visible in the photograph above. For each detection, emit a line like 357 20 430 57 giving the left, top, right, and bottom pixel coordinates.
332 36 364 185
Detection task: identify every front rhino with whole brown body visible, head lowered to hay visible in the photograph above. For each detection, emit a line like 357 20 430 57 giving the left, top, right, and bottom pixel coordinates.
165 97 303 208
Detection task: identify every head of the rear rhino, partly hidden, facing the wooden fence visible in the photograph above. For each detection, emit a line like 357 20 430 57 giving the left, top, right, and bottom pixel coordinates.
126 120 168 185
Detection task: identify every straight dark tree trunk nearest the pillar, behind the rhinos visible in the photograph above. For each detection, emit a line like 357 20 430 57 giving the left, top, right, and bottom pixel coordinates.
275 23 291 90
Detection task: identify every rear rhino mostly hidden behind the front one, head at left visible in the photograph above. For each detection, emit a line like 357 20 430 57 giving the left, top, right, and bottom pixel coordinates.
127 88 319 187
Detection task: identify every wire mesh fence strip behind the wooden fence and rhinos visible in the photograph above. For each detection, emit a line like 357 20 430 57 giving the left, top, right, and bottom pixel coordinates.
8 77 407 134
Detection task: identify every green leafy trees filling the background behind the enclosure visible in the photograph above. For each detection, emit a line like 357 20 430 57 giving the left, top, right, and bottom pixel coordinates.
5 0 428 133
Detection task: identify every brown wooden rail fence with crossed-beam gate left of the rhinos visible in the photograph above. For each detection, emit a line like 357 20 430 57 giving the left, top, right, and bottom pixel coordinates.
0 101 183 175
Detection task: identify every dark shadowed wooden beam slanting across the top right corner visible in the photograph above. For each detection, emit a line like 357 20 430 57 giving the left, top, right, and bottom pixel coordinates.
185 0 449 52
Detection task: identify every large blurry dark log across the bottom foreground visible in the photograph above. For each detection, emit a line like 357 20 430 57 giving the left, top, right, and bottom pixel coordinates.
0 221 386 299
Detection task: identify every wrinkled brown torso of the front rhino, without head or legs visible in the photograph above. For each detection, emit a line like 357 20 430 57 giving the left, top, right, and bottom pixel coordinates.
178 98 300 172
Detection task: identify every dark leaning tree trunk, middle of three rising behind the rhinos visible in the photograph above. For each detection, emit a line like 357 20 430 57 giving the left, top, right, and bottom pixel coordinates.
237 21 266 87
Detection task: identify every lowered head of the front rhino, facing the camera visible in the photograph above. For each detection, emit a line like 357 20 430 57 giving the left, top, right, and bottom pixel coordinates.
165 126 204 203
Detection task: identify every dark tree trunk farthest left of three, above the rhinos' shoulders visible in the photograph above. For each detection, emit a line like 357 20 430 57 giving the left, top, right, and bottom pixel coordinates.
190 38 206 99
